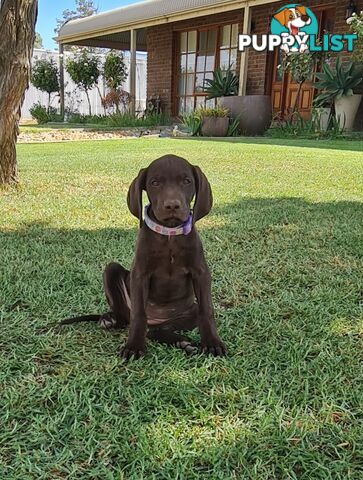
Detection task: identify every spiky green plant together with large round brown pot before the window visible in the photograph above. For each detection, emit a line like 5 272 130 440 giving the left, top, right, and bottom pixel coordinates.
204 68 272 135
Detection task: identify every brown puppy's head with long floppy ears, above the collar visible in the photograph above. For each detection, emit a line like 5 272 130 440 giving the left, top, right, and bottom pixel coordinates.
127 155 213 228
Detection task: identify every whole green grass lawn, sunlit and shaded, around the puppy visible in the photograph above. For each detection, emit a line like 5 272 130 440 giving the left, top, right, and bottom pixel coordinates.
0 139 363 480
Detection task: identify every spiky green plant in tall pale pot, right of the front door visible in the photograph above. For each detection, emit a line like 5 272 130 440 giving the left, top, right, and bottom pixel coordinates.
314 57 362 131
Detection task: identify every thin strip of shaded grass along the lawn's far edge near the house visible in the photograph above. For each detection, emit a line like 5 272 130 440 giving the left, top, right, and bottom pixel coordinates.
177 137 363 152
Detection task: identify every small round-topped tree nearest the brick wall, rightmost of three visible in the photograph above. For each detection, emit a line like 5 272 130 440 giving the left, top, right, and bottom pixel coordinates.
103 51 127 112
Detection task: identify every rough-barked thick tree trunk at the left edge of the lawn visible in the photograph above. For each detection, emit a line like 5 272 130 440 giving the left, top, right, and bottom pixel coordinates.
0 0 38 185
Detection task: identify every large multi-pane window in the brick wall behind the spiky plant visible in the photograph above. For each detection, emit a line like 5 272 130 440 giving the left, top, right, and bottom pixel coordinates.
177 24 238 114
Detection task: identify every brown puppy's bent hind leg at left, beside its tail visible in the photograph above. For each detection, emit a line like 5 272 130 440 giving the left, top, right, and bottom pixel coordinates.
98 263 131 330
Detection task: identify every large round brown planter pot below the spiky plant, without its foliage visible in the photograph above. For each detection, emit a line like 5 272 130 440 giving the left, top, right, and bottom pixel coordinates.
219 95 272 136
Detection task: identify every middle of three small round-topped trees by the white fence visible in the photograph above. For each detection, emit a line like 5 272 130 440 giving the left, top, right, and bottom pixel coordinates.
66 50 100 115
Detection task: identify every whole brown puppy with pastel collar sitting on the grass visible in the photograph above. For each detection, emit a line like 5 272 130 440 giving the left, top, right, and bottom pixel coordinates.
62 155 226 359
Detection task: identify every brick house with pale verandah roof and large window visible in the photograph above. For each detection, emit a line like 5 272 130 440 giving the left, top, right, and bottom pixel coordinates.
57 0 363 123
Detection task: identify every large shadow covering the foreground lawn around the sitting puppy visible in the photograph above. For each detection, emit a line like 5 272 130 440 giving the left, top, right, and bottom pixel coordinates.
0 198 362 480
